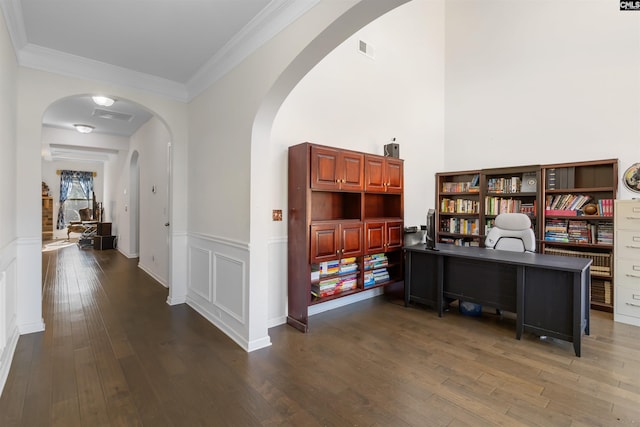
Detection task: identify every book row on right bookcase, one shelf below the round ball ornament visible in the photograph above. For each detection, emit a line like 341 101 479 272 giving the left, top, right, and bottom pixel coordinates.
544 219 613 245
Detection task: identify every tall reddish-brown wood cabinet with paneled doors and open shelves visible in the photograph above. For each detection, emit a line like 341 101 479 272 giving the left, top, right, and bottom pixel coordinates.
287 143 404 332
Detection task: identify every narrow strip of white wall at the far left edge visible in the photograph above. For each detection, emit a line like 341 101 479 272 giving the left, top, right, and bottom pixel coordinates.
0 4 19 398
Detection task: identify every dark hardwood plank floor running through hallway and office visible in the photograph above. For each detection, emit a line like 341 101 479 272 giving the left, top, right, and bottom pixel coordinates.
0 246 640 427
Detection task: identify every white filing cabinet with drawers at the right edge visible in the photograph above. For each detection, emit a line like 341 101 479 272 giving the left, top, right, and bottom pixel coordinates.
613 200 640 326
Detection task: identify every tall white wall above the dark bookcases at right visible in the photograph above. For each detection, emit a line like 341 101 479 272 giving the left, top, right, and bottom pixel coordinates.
444 0 640 198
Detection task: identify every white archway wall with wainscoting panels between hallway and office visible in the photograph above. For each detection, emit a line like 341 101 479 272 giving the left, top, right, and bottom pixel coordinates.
187 0 410 350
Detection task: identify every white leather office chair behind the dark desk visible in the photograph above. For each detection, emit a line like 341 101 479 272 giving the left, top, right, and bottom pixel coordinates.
484 213 536 252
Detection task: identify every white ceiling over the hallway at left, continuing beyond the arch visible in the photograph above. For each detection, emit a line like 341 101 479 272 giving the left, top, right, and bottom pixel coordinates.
0 0 319 159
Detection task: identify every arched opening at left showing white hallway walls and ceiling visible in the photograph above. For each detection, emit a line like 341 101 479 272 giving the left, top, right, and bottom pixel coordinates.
41 94 171 287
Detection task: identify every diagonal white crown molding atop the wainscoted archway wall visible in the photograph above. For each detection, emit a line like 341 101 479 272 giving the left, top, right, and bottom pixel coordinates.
187 0 320 100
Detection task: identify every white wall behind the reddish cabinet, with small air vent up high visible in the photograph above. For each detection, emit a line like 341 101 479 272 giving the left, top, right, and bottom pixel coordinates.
268 0 444 325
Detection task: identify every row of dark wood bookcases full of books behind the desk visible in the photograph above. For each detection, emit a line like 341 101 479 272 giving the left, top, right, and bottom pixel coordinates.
436 159 618 311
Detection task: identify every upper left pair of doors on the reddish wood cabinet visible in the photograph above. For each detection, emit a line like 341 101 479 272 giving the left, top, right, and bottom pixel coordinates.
311 146 364 191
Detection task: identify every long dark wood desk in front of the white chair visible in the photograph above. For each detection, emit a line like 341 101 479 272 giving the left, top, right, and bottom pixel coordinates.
404 244 591 356
